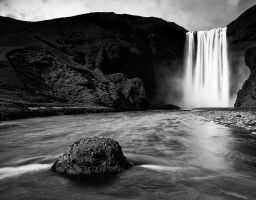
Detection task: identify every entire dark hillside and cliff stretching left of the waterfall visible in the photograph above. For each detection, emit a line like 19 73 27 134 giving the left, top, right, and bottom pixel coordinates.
0 13 186 117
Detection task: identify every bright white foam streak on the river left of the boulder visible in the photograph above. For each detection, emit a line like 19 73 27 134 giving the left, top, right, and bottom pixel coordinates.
0 164 51 180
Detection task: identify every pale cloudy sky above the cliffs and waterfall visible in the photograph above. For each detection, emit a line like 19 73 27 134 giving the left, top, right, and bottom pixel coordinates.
0 0 256 30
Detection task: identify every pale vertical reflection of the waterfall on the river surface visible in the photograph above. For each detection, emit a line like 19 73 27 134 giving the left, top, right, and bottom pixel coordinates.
188 122 233 172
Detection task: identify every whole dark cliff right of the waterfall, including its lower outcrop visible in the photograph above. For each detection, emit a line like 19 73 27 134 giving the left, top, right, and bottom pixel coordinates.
227 6 256 108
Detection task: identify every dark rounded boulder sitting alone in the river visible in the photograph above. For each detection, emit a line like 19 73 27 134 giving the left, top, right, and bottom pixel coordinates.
52 137 131 176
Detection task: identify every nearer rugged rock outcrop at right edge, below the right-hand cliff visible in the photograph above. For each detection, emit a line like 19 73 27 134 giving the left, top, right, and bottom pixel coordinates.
235 47 256 108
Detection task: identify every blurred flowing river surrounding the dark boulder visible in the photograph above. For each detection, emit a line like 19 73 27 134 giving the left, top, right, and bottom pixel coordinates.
0 111 256 200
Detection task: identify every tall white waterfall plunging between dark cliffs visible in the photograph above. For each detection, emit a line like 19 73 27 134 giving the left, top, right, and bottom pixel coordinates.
183 28 230 108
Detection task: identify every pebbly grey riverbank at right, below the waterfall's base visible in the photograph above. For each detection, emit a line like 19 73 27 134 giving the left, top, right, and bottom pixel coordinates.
194 108 256 131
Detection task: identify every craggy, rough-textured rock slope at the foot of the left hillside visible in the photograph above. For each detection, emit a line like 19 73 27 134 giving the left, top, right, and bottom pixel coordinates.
7 48 145 110
